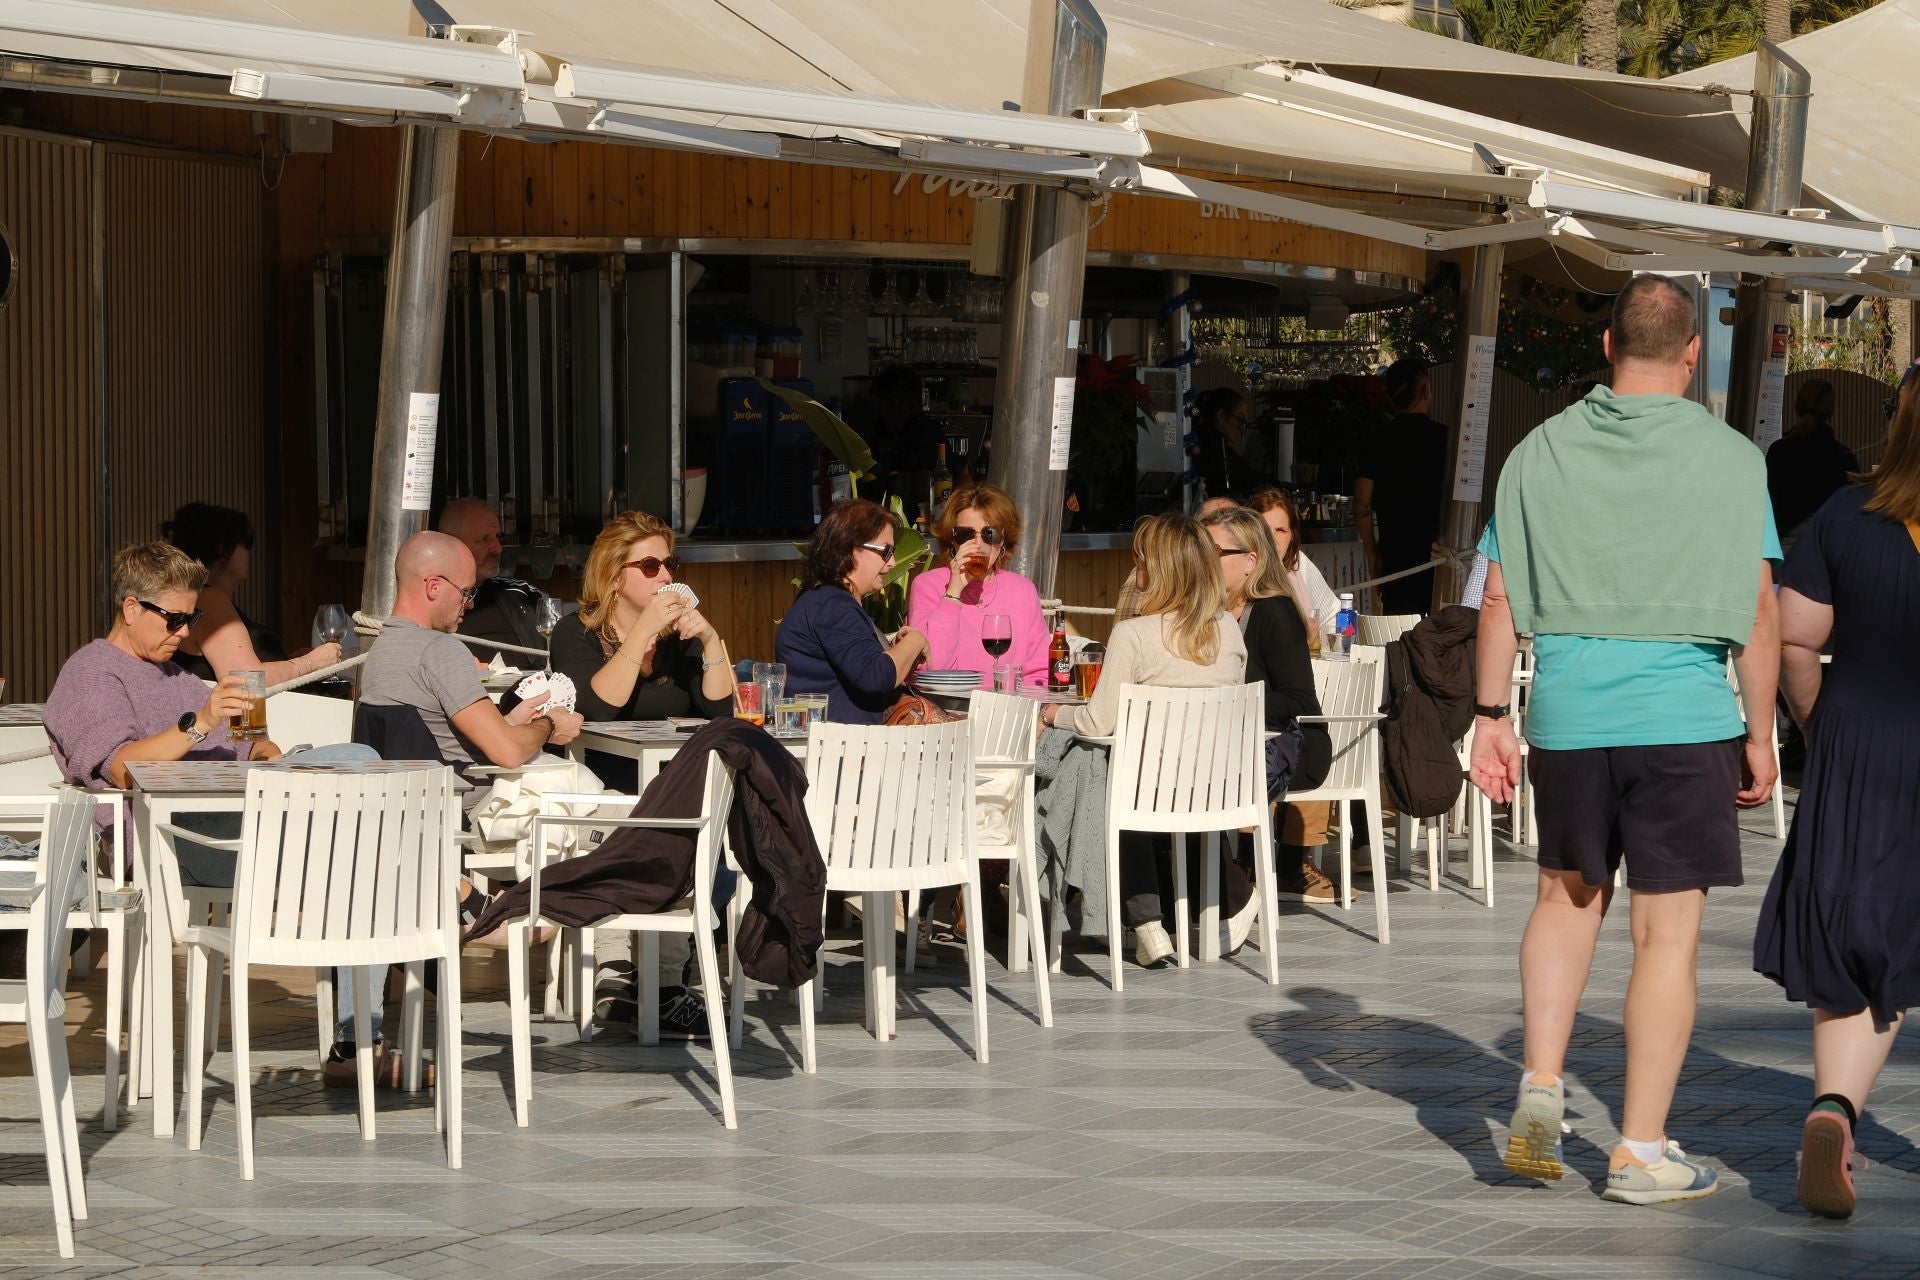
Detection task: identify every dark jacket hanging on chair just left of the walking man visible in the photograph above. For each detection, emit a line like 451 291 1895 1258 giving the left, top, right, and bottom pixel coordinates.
1380 604 1480 818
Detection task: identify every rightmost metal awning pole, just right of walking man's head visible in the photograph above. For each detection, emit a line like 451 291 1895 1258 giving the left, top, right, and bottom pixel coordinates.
1726 40 1812 436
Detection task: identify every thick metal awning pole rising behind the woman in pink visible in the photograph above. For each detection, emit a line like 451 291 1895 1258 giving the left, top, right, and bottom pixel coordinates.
987 0 1106 599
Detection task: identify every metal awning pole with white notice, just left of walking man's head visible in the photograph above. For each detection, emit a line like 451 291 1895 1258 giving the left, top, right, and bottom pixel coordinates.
1432 244 1507 608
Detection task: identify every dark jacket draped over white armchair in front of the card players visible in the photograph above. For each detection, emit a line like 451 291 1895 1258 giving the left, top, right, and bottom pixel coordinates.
467 720 828 998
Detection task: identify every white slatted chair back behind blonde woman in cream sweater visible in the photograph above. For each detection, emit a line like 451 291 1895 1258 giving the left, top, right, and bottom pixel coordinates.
1106 683 1267 831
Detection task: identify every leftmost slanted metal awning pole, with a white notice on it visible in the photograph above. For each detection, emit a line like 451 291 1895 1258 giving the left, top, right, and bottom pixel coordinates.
361 125 461 618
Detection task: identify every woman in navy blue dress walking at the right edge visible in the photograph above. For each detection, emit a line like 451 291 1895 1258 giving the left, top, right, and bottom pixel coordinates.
1753 374 1920 1219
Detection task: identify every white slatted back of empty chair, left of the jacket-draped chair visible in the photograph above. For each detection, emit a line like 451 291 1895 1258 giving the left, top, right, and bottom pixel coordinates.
234 766 459 965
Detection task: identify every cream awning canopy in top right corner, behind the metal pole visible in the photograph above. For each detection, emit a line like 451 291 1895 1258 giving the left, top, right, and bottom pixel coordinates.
1672 0 1920 223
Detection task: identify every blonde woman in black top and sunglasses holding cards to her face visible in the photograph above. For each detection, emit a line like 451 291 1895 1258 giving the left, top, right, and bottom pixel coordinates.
553 510 733 791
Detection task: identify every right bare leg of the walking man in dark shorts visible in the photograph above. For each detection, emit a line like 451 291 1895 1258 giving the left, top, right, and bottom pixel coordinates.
1617 889 1707 1155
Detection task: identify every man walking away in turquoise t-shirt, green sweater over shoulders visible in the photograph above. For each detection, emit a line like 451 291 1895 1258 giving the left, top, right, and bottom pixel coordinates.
1473 276 1780 1205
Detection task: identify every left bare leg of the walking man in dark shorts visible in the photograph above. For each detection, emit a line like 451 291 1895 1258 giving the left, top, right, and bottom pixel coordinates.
1521 871 1613 1084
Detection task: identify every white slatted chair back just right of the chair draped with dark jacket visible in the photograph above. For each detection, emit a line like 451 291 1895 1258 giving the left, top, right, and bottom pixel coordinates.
806 722 973 892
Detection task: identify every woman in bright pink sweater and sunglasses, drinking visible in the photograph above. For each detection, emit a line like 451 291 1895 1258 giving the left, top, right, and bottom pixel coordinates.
906 484 1052 687
